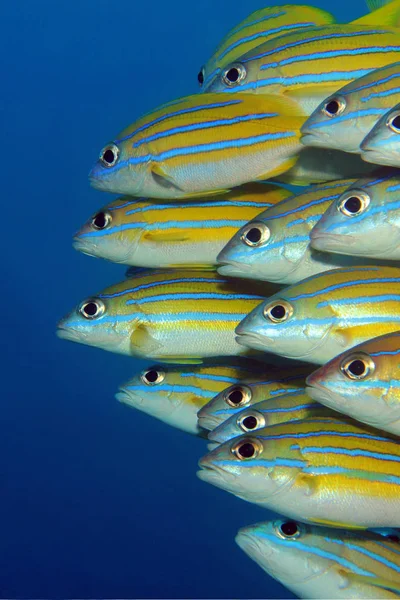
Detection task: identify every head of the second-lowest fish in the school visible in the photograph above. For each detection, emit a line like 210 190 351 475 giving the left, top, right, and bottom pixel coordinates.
197 429 300 504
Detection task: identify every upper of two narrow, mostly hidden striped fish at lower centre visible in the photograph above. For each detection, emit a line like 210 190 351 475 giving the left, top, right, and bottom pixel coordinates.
197 363 313 430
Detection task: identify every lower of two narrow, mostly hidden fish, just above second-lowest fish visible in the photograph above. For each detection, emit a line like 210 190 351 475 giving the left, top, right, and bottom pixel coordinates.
208 388 337 444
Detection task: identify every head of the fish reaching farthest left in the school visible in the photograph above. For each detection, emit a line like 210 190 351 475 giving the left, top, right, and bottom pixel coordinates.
57 282 140 354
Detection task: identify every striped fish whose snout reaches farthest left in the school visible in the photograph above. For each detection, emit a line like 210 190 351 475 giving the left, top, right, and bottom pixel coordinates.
57 269 280 363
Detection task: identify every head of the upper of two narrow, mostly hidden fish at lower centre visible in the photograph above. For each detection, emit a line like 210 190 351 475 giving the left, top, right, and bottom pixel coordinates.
197 383 257 431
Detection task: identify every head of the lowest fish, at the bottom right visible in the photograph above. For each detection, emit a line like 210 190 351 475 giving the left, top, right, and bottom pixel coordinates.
236 519 356 598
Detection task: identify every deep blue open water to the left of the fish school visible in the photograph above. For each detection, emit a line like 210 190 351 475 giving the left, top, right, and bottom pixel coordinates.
0 0 365 598
